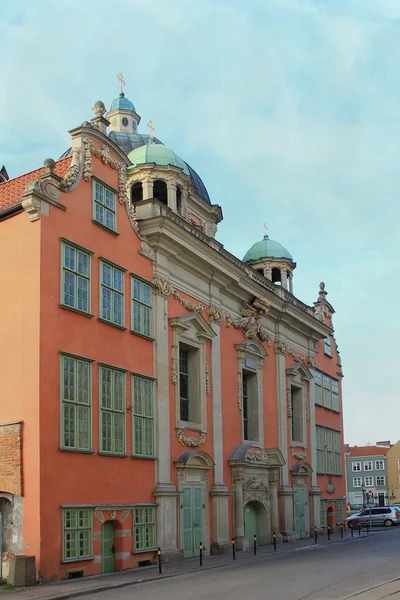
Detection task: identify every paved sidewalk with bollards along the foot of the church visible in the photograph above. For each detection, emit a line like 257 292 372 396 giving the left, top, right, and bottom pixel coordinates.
0 531 372 600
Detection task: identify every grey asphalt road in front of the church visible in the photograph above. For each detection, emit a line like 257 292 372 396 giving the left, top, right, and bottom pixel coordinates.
72 526 400 600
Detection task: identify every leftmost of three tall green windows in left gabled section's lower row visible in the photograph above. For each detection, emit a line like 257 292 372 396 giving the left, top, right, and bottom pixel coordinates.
61 355 92 450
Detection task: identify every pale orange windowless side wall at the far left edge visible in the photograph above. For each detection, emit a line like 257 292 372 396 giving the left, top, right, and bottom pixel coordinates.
0 212 41 559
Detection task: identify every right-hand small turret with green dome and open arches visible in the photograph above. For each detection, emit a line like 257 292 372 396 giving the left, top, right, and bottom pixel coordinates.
243 235 296 293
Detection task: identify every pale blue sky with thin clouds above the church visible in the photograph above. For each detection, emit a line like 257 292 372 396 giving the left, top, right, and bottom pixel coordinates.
0 0 400 445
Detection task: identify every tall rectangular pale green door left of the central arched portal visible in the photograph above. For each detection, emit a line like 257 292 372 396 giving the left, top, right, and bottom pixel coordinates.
182 485 204 558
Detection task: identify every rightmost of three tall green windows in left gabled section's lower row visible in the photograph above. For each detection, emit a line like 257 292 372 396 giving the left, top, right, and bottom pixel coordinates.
132 375 155 457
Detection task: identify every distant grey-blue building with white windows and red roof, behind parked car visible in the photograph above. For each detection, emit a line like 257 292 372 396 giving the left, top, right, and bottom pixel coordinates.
345 442 390 509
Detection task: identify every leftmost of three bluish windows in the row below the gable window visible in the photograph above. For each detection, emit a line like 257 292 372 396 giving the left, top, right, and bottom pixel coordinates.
61 242 90 313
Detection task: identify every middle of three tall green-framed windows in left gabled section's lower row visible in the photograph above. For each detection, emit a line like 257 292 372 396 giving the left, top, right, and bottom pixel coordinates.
99 367 126 454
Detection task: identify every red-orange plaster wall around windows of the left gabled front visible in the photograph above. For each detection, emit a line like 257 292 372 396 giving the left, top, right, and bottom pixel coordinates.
40 158 155 579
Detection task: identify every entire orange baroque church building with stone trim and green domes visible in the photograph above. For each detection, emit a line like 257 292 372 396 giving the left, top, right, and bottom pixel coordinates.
0 82 346 580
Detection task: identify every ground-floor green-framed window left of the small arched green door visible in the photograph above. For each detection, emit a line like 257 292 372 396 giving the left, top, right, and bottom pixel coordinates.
63 508 93 560
